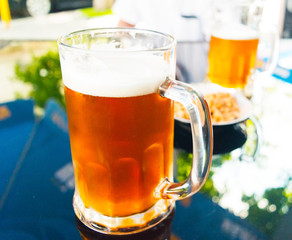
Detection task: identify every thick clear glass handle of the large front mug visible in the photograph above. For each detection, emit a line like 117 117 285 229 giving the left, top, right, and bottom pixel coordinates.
154 78 213 200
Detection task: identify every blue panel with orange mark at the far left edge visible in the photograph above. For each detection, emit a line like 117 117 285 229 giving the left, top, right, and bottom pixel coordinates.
0 100 35 199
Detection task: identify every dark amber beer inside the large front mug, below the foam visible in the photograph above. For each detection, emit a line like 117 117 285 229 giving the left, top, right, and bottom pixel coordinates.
65 87 174 217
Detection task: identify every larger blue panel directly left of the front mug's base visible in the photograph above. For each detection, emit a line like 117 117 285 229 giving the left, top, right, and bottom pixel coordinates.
0 101 80 240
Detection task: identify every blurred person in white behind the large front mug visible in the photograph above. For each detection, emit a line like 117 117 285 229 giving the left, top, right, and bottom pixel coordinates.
113 0 214 83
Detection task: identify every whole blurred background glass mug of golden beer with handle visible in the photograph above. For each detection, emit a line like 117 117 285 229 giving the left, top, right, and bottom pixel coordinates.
207 0 279 89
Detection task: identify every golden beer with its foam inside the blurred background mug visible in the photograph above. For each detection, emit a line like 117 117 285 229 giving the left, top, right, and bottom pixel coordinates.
208 27 259 89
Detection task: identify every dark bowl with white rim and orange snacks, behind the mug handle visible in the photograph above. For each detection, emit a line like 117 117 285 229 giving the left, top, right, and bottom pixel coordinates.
174 83 252 154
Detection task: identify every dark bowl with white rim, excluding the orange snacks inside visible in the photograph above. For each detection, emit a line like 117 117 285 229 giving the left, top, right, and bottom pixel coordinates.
174 84 252 154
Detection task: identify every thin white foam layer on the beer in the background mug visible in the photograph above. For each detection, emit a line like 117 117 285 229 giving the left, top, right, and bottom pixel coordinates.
212 25 259 40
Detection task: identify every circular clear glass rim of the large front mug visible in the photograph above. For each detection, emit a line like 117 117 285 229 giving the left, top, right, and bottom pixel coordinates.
57 27 177 53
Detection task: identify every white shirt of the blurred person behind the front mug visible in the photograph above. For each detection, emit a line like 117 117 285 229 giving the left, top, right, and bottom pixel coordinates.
113 0 213 41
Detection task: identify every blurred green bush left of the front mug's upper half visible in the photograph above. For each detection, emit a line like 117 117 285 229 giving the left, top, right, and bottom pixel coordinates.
14 50 65 108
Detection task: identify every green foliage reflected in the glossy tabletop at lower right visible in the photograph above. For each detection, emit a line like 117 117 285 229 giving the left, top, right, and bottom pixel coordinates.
176 151 292 237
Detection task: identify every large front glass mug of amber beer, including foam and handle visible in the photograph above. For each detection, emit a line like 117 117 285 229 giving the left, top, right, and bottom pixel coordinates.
58 28 213 234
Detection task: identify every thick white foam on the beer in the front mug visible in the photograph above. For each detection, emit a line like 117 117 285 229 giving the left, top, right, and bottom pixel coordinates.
61 53 172 97
